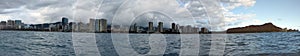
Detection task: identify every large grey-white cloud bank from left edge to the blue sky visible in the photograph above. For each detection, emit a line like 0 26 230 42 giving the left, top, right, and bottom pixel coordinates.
0 0 256 30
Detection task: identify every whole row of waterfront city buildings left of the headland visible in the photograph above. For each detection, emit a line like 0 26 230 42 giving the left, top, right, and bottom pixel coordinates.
0 17 209 33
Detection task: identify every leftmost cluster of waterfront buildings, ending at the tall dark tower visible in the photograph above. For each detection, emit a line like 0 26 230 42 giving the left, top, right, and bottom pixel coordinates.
0 17 74 32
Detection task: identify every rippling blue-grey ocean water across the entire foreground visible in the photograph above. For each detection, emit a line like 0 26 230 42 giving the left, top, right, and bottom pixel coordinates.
0 31 300 56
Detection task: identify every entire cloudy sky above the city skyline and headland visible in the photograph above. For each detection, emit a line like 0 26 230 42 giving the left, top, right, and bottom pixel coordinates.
0 0 300 31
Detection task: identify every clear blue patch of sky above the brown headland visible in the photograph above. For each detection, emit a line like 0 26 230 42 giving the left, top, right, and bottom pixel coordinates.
232 0 300 29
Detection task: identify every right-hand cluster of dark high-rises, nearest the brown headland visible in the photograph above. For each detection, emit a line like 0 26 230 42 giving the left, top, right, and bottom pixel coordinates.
129 22 199 33
